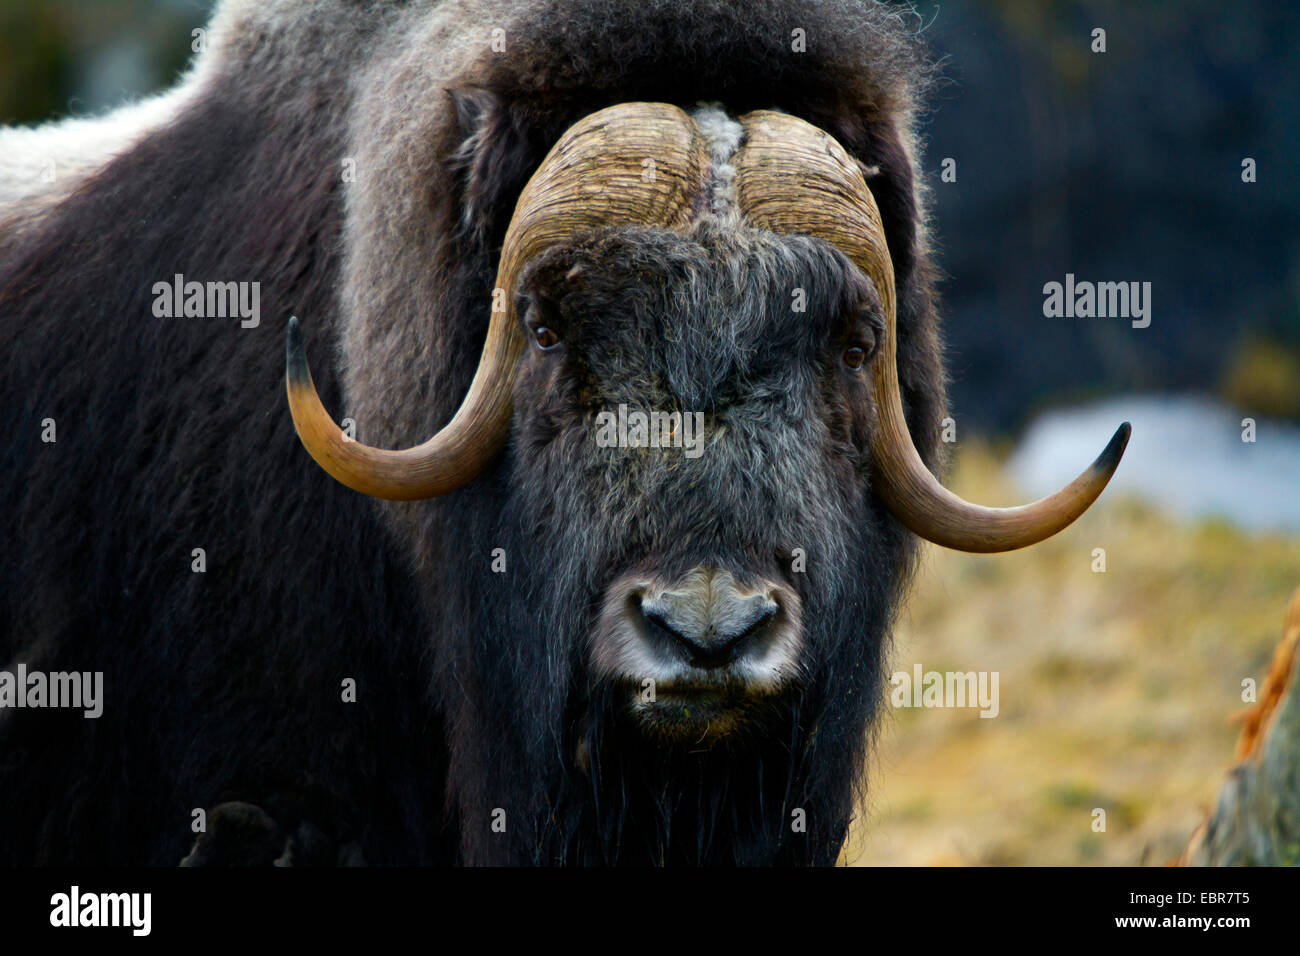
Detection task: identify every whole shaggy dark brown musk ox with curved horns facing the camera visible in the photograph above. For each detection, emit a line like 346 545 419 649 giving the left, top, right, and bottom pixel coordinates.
0 0 1127 864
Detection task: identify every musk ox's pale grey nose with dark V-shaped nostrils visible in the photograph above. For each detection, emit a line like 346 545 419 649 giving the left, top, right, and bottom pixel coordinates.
640 567 781 667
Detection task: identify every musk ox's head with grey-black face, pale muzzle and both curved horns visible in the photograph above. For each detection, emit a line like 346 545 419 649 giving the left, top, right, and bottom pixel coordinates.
287 103 1127 741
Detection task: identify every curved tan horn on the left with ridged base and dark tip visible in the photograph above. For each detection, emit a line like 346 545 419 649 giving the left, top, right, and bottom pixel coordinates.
285 103 709 501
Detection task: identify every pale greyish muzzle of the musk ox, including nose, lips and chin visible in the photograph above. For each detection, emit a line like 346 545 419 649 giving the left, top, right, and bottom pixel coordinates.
592 567 802 739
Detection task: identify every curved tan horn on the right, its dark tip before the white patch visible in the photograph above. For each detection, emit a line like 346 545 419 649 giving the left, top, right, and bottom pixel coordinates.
733 111 1130 551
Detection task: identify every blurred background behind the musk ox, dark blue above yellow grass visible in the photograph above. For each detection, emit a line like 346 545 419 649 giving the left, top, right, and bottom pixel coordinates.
0 0 1300 864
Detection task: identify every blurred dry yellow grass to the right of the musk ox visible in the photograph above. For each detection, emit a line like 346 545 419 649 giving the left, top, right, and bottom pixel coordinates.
841 447 1300 865
